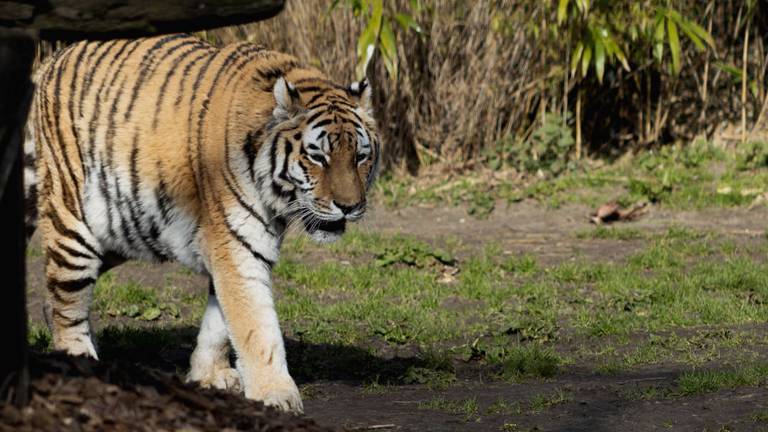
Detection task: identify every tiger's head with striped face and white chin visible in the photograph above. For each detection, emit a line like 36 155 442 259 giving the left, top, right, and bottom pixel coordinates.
268 77 379 243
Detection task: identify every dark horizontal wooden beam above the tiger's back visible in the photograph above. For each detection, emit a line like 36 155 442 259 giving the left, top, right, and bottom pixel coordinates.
0 0 285 39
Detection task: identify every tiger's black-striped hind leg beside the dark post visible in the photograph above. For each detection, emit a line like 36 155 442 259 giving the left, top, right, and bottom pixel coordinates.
41 211 103 359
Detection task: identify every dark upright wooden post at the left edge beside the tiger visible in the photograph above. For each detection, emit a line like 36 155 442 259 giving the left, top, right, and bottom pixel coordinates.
0 34 35 404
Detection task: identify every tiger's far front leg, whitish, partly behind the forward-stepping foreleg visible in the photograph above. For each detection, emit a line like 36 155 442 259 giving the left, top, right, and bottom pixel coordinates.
187 282 242 391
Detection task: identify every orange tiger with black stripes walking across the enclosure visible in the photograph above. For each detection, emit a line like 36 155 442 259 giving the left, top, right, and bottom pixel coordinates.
25 34 380 413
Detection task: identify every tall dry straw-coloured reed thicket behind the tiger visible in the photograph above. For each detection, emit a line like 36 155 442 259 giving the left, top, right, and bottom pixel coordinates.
37 0 768 174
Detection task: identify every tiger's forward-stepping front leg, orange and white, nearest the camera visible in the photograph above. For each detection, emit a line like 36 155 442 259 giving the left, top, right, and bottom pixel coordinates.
210 234 303 413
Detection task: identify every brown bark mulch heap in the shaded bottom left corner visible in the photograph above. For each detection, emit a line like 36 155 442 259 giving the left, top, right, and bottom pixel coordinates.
0 354 335 432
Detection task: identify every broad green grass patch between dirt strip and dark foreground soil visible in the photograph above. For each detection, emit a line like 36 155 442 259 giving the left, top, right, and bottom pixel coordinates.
275 227 768 382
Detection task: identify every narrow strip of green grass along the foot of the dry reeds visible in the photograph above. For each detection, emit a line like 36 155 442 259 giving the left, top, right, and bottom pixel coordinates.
376 140 768 217
